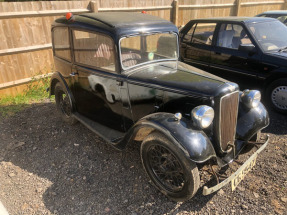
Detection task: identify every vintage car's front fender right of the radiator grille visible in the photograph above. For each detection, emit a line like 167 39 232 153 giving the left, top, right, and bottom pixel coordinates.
236 102 269 141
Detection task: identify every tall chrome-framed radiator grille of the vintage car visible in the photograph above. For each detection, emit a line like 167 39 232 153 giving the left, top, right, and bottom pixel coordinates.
219 92 239 151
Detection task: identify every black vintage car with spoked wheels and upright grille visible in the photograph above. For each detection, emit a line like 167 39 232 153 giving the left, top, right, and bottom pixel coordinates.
50 13 269 201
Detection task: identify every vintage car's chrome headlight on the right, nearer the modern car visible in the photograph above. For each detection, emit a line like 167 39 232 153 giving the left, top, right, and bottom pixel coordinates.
240 90 261 108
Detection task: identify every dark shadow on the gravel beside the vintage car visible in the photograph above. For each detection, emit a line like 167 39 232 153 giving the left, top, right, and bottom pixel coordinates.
0 103 218 214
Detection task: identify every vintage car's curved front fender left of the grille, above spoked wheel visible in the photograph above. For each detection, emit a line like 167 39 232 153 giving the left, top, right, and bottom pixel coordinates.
119 113 216 163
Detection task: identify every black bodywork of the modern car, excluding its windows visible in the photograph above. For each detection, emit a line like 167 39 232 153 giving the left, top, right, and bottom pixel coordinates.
179 17 287 93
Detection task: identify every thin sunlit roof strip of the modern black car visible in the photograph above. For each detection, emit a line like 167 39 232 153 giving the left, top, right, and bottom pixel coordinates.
192 16 274 23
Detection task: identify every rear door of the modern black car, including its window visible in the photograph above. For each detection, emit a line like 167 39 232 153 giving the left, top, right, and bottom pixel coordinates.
180 22 216 71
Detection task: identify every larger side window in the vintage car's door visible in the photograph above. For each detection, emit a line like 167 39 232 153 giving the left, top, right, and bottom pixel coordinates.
73 30 116 72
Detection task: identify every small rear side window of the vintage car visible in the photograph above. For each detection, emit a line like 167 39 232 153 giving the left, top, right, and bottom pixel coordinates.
53 27 71 61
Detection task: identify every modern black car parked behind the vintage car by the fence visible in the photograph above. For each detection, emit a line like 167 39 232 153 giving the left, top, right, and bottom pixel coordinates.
180 17 287 113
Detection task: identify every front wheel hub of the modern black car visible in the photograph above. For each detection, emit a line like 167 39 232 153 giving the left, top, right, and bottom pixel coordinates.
271 86 287 110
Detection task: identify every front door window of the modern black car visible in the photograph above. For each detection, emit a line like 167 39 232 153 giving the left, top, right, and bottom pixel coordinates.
216 24 252 49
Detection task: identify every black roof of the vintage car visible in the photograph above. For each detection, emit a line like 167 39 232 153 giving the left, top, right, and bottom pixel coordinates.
52 12 178 37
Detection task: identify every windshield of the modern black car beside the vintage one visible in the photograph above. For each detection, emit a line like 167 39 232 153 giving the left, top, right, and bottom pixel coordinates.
248 21 287 52
